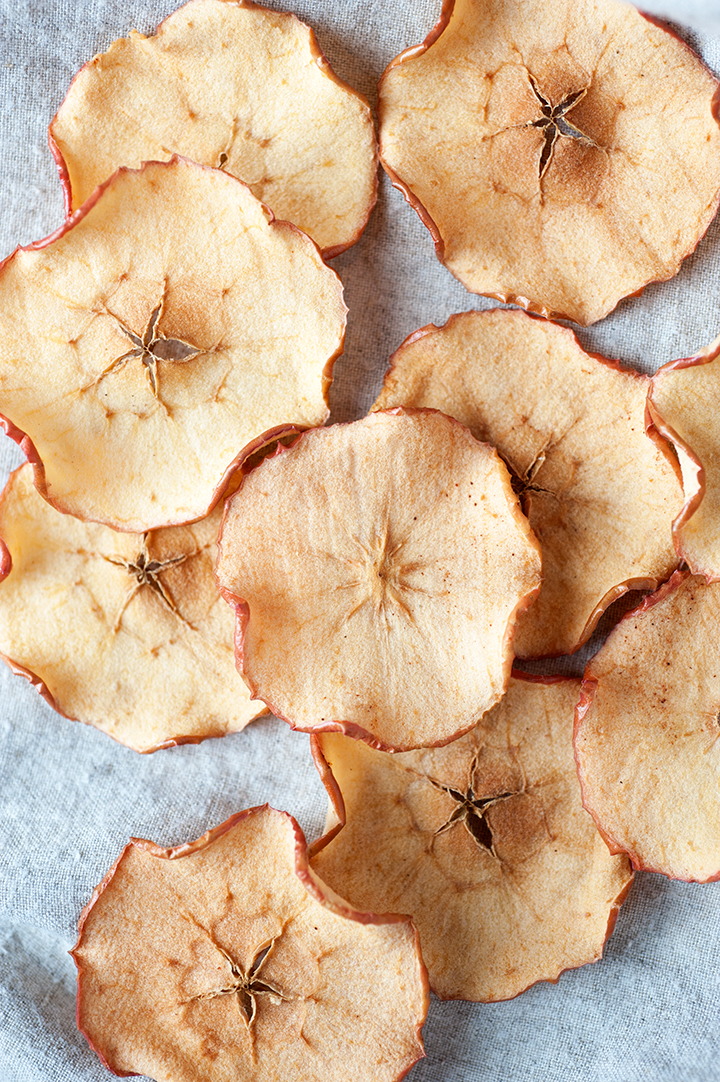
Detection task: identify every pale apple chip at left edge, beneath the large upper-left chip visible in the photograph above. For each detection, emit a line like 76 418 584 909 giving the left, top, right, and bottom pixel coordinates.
0 465 265 752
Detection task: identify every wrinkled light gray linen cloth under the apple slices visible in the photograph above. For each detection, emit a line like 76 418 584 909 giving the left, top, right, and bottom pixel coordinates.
0 0 720 1082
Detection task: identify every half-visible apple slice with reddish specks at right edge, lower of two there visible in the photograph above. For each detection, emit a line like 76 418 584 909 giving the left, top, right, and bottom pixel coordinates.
575 571 720 883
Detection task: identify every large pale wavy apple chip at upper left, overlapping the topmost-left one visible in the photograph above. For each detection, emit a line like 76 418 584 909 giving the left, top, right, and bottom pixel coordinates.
0 158 345 532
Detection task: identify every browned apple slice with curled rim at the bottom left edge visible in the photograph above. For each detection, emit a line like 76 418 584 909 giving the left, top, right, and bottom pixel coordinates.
73 805 428 1082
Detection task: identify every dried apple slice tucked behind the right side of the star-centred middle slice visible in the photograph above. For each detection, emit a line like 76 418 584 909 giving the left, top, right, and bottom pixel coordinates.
374 309 682 658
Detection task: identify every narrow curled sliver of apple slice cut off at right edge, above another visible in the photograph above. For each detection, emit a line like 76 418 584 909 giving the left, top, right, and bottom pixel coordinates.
647 339 720 581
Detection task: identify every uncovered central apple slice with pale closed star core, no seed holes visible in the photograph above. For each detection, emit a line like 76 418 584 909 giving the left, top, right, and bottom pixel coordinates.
214 410 539 749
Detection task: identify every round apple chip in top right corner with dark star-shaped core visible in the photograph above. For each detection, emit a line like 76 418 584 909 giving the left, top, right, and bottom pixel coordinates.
379 0 720 324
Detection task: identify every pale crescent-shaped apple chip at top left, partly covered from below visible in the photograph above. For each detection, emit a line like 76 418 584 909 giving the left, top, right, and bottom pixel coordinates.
50 0 377 258
